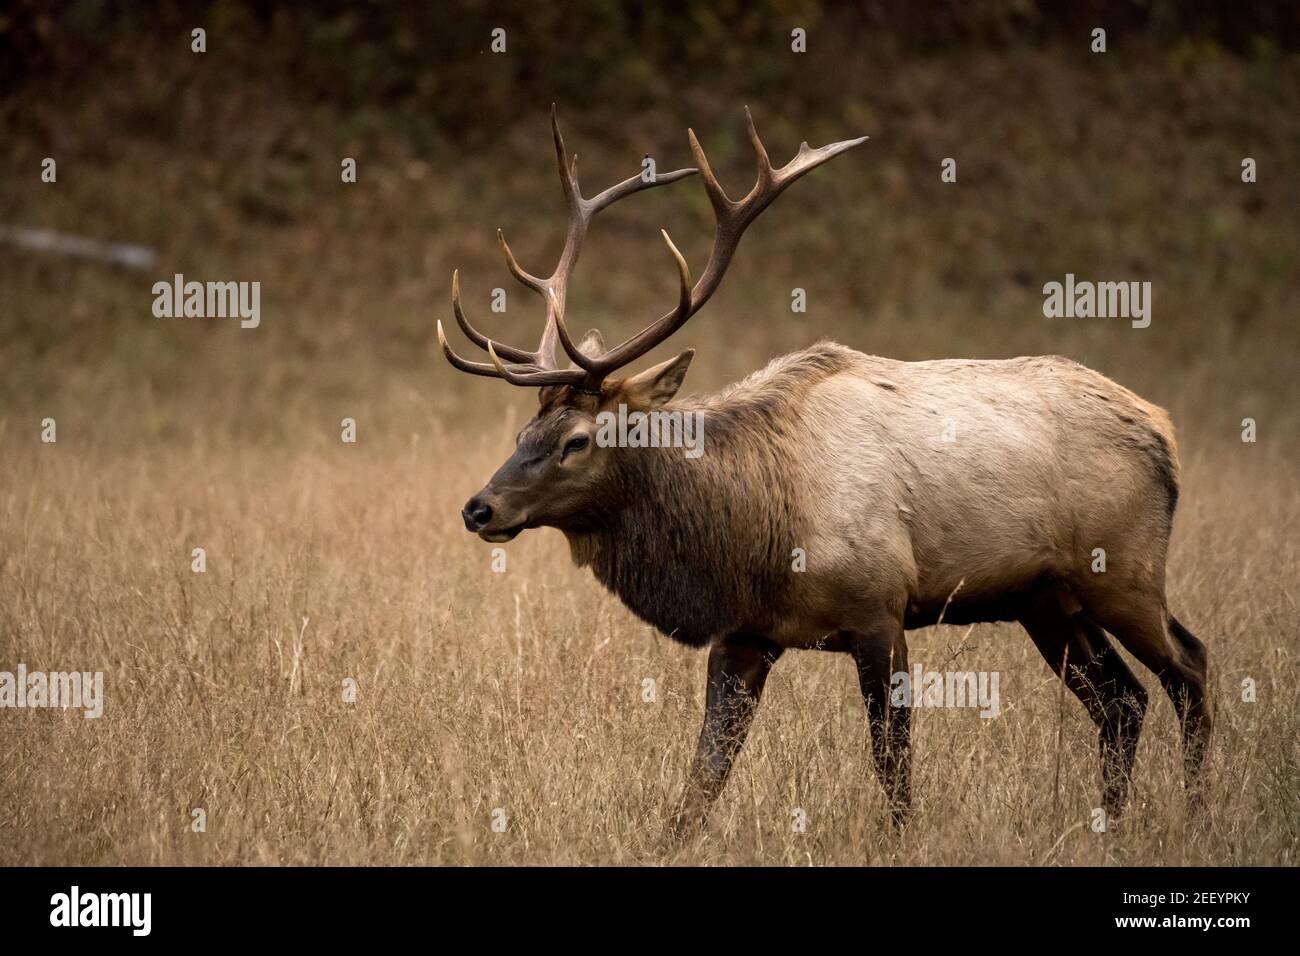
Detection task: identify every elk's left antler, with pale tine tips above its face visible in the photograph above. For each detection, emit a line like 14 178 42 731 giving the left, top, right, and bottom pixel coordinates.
438 104 697 385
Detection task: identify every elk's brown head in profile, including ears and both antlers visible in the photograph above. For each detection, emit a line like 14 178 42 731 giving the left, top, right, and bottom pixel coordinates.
438 105 867 541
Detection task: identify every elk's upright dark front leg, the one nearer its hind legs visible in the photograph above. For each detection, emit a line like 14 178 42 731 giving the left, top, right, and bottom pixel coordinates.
842 622 911 826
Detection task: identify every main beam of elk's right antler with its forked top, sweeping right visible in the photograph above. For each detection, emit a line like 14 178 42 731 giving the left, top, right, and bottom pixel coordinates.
584 107 867 378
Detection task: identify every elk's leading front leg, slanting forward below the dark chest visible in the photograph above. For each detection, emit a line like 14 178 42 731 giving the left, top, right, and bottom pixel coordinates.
673 633 781 835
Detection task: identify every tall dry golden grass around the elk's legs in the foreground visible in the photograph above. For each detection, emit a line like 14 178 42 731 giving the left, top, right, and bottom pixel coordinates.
0 442 1300 864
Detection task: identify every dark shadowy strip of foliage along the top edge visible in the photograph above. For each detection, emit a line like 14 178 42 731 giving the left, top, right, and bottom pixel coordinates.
0 0 1300 135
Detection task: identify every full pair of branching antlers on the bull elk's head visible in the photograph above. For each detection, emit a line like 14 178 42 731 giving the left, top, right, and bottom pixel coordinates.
438 107 867 392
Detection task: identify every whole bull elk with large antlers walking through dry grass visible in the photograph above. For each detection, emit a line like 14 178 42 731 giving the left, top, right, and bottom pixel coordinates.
438 108 1210 827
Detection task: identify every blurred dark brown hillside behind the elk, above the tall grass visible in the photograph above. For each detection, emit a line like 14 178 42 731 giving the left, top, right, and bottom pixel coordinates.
0 0 1300 445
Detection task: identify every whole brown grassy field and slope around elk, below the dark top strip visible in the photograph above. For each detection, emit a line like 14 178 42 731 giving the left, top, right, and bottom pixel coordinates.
0 14 1300 865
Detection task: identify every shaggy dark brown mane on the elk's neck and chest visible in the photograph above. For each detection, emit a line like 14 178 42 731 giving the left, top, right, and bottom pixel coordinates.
566 346 853 646
